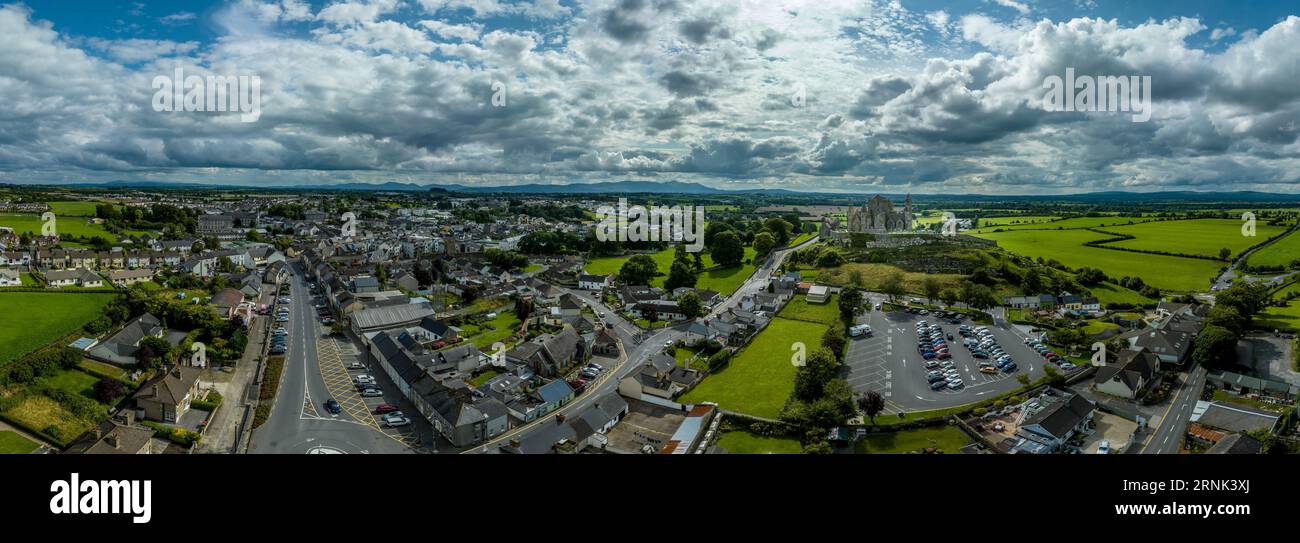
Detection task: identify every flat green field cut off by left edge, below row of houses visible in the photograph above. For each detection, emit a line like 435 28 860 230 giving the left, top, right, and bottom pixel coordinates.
0 292 113 365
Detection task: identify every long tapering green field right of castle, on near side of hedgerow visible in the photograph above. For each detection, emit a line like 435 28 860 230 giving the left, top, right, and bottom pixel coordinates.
976 230 1222 292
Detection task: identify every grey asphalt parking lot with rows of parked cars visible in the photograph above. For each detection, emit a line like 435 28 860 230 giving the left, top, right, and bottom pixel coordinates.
845 303 1044 413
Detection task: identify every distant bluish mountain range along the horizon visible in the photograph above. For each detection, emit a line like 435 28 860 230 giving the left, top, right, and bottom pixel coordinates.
25 181 1300 203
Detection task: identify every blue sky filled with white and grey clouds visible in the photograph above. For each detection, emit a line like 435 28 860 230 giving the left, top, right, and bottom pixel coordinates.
0 0 1300 195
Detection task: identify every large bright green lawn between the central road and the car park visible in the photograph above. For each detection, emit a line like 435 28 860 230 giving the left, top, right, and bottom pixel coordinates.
680 317 827 418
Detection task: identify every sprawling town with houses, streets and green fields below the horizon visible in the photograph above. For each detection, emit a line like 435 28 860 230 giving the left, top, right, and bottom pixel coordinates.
0 186 1300 455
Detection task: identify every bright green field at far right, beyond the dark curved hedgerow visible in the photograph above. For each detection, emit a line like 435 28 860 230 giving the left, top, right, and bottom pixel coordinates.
1105 218 1286 257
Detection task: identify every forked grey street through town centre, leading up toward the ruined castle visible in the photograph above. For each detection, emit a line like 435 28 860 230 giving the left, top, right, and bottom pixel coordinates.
464 236 816 452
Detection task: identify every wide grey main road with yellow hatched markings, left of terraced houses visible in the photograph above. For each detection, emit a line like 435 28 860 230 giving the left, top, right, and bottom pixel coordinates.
248 264 412 453
